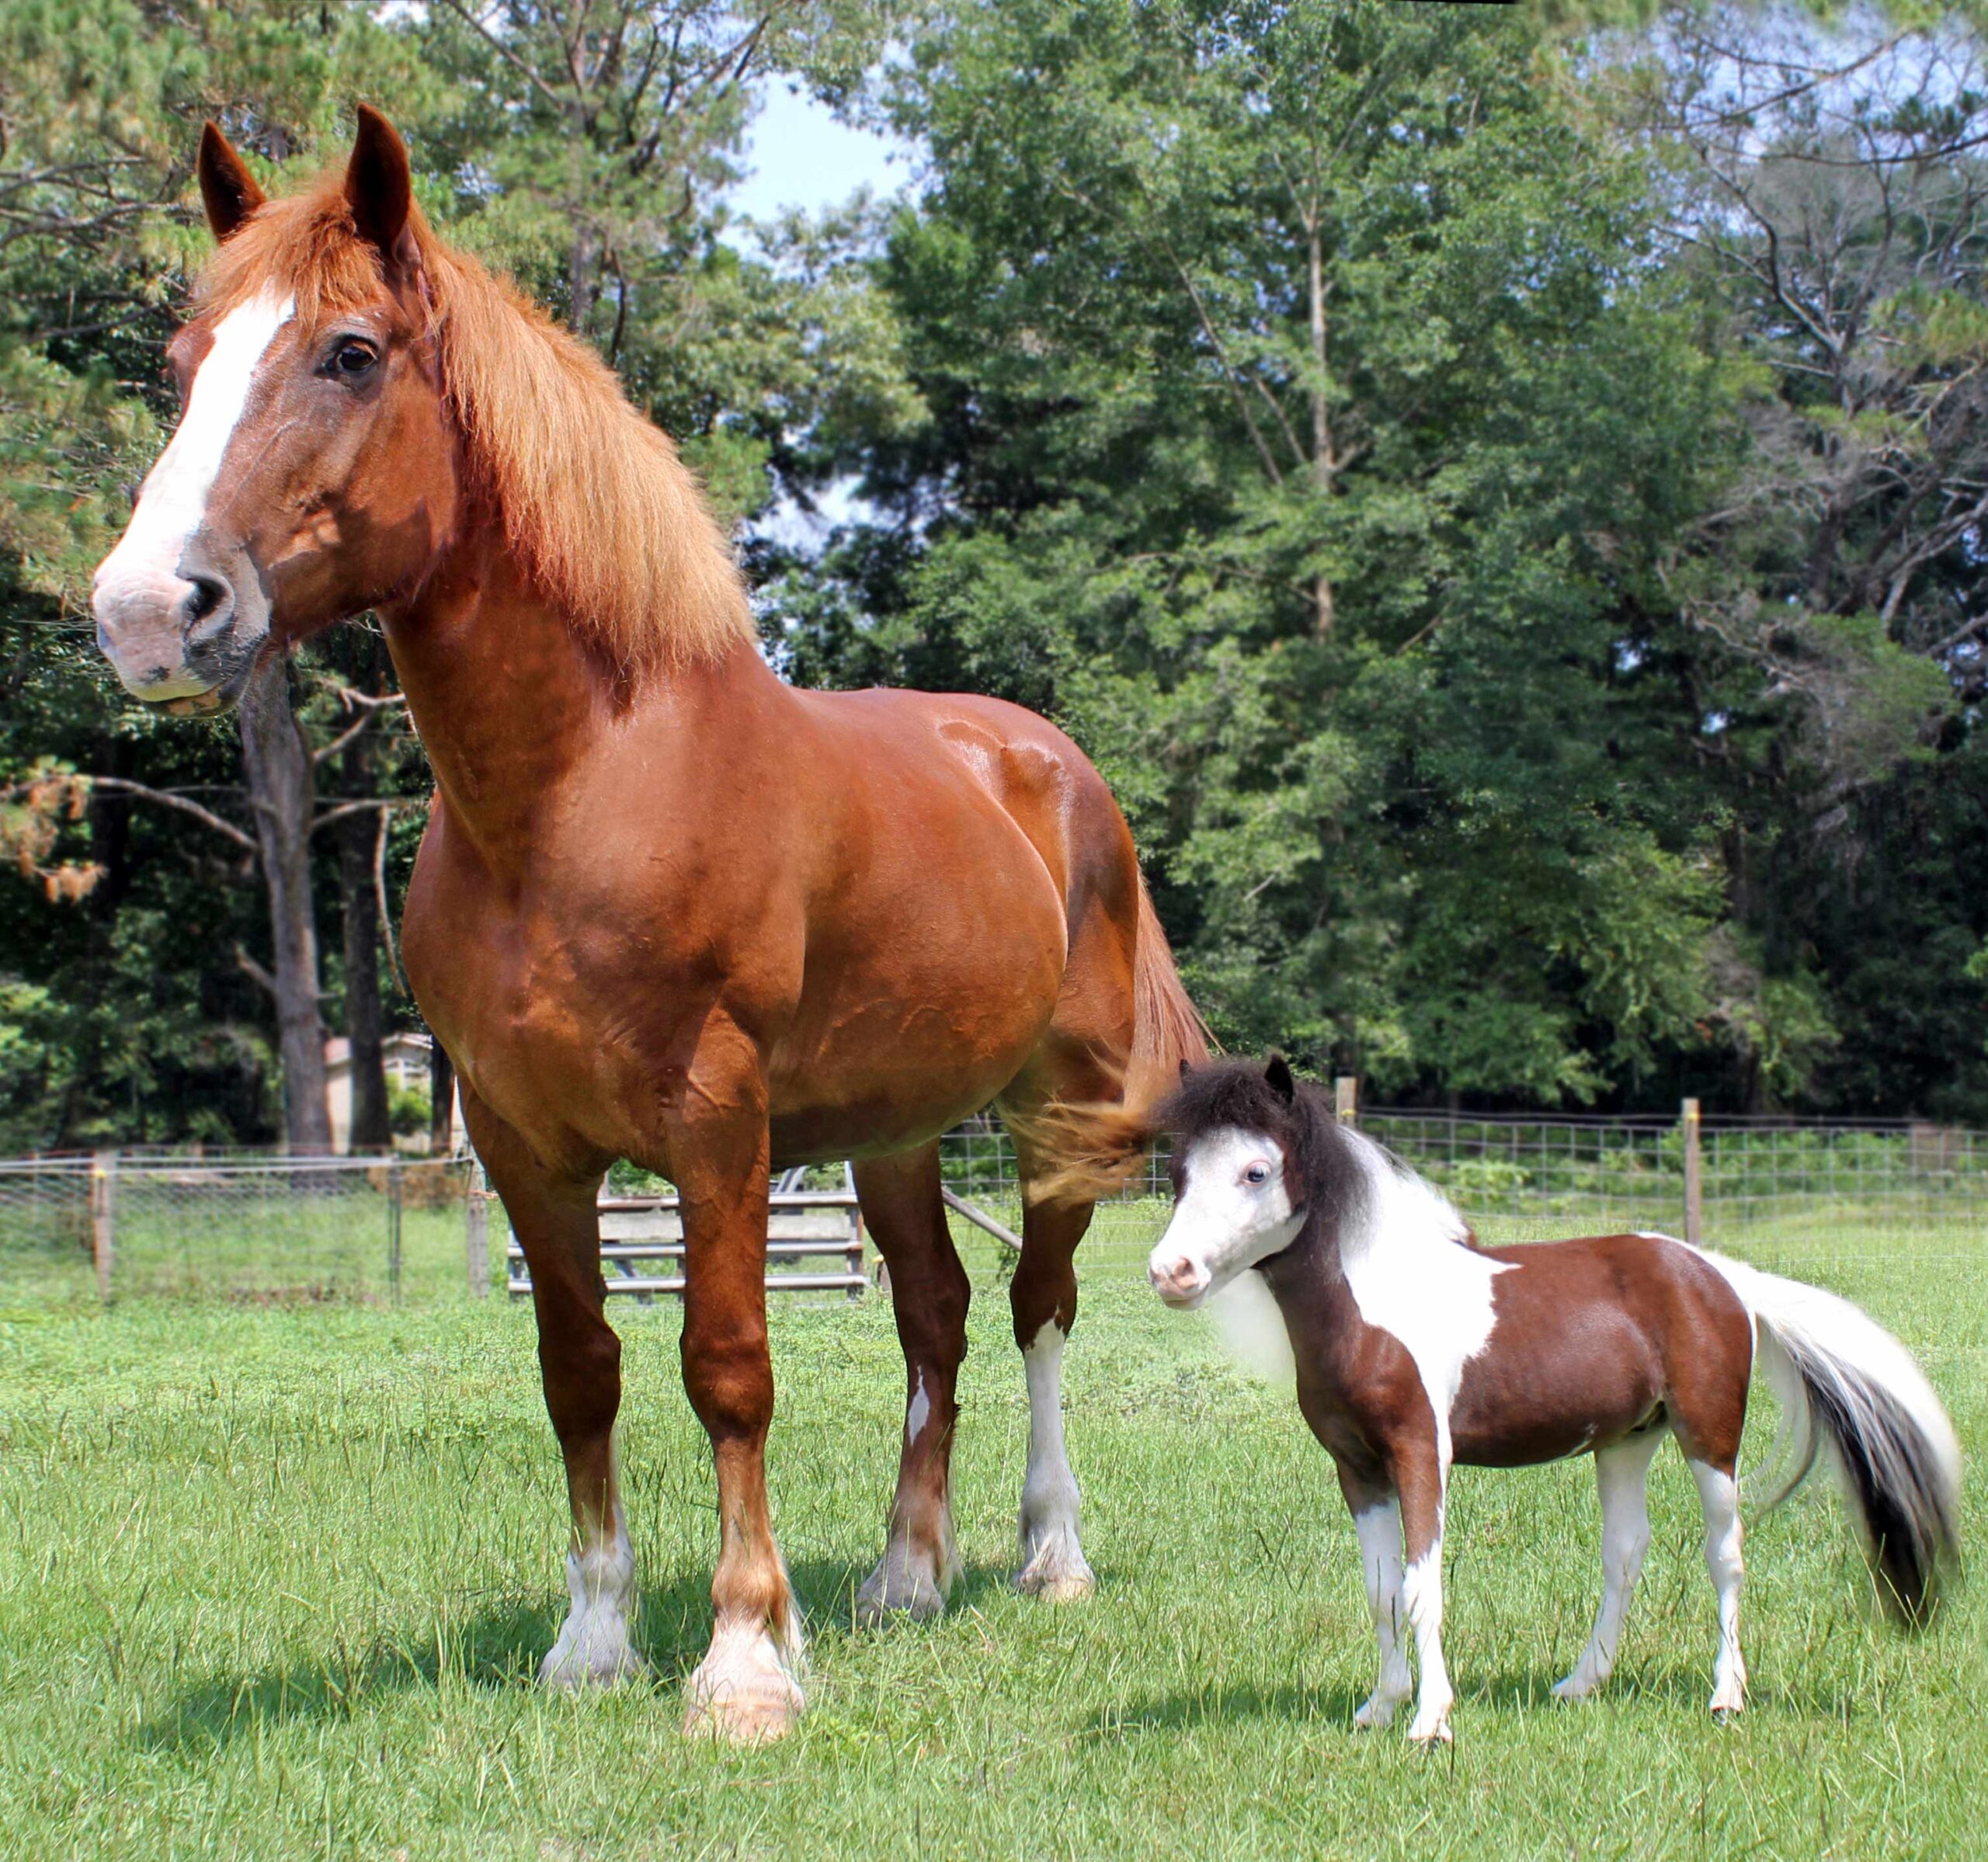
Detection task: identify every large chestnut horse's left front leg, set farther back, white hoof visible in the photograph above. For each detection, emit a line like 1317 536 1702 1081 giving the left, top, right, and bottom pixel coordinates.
463 1083 642 1687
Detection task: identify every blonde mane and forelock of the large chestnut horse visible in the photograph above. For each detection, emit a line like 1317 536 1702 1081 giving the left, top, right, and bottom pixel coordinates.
196 173 756 672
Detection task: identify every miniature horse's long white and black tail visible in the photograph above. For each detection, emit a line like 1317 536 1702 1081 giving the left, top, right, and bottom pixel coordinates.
1705 1254 1960 1624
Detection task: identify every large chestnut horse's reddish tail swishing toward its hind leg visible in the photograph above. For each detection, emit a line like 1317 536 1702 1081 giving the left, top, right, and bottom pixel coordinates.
1002 874 1215 1202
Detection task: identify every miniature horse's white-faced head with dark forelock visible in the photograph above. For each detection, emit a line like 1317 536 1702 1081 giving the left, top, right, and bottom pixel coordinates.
1147 1055 1320 1308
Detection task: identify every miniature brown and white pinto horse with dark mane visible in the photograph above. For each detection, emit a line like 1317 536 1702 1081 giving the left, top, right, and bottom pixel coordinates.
1128 1059 1960 1741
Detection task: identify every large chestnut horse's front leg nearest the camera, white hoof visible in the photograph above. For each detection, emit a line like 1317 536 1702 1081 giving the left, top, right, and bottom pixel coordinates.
668 1055 801 1741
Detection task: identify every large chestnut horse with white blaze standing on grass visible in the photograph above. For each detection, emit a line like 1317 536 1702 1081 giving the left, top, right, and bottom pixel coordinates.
96 109 1204 1737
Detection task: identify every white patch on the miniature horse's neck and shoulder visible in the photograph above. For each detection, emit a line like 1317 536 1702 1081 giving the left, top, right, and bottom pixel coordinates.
1340 1131 1509 1472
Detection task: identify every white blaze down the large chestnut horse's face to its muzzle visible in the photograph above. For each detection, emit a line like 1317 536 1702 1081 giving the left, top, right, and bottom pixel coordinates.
93 290 296 697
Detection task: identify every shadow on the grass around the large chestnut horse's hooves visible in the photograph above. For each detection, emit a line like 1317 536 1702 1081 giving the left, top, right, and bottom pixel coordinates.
137 1558 1008 1753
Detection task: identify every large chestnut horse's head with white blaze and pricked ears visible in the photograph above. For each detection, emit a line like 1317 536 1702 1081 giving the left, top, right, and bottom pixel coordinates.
93 107 457 711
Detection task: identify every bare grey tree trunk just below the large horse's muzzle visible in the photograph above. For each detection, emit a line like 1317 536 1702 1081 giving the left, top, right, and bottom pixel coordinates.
241 654 332 1152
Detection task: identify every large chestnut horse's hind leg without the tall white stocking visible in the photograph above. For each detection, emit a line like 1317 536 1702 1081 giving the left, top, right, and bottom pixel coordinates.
855 1143 970 1624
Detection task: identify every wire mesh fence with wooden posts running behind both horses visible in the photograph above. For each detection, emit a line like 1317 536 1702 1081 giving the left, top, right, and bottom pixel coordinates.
0 1106 1988 1301
